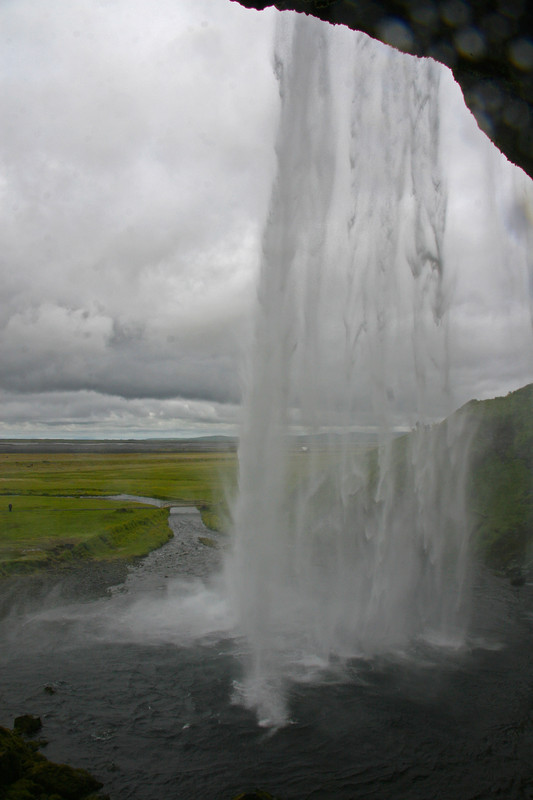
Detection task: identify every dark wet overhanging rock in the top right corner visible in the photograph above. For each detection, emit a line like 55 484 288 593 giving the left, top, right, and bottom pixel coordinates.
231 0 533 177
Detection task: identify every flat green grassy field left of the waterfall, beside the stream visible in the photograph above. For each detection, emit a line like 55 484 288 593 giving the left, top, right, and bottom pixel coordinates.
0 453 236 576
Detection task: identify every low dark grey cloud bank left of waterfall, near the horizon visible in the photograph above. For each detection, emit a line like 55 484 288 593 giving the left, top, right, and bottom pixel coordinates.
0 305 242 403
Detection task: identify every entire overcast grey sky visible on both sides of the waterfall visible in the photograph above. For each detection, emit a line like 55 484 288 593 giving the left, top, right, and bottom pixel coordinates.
0 0 533 438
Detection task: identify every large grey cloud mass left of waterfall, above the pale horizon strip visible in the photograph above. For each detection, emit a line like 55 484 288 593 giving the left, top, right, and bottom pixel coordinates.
0 0 277 438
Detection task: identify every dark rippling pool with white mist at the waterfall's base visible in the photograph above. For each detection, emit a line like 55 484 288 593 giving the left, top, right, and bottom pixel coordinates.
0 517 533 800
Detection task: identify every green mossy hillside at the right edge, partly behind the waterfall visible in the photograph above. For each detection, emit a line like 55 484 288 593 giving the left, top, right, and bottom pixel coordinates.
369 384 533 581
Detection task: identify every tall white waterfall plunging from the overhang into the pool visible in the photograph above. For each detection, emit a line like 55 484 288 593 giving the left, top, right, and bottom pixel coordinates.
227 14 474 725
